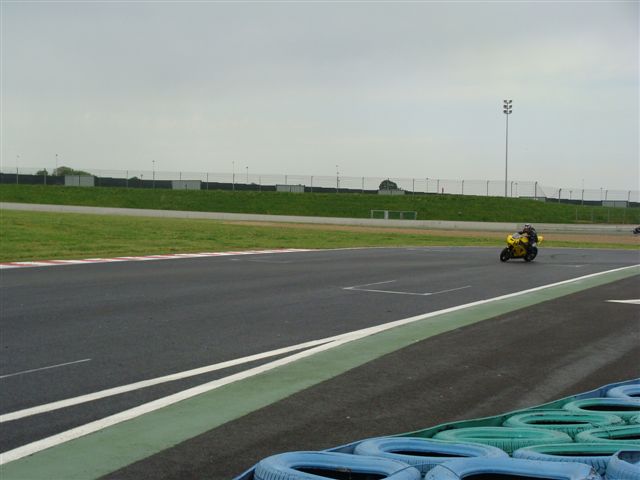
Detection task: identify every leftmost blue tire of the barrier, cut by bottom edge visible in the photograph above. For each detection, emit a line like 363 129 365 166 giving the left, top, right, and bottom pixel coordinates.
253 452 422 480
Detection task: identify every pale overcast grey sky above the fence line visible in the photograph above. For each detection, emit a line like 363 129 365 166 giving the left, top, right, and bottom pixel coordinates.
0 0 640 190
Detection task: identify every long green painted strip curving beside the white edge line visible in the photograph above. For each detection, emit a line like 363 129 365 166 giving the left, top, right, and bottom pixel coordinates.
0 266 640 480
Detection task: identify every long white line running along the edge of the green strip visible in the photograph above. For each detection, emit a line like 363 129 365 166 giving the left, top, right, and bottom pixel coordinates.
0 264 640 465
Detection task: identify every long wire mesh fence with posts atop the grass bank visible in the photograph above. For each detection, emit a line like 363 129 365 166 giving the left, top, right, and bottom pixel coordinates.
0 167 640 206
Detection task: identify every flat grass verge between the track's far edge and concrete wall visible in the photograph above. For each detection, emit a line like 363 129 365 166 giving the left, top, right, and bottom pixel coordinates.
0 210 633 262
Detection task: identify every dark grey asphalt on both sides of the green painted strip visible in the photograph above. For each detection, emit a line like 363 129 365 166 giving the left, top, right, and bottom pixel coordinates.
0 247 640 478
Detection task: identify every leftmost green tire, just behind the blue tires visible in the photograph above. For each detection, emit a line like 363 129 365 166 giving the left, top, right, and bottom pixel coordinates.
433 427 571 455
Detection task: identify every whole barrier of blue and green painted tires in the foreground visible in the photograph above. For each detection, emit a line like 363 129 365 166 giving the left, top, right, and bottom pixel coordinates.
236 381 640 480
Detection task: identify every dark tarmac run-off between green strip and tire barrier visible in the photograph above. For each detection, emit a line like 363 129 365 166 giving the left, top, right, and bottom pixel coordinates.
104 277 640 480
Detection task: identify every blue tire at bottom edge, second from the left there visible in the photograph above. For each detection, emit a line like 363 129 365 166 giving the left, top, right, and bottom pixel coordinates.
425 458 602 480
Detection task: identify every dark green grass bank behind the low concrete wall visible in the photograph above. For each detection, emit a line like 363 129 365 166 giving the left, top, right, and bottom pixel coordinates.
0 184 640 224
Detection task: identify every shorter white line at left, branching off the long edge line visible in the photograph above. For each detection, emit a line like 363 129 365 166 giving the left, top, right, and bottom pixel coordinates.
0 337 337 424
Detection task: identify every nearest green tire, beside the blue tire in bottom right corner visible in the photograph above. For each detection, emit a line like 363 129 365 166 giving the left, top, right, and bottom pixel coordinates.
513 442 638 475
